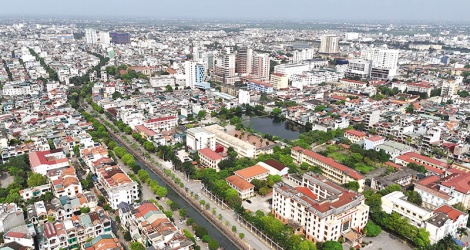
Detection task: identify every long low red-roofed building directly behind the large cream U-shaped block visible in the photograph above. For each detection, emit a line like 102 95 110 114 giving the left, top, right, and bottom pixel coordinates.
291 147 365 192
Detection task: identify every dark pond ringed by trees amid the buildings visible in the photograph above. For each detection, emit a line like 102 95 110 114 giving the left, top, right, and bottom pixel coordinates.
243 117 305 140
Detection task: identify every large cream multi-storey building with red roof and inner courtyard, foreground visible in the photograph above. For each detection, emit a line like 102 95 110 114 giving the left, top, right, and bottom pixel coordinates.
272 173 369 246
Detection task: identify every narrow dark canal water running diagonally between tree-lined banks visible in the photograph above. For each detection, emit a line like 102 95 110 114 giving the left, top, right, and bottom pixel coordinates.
113 138 237 249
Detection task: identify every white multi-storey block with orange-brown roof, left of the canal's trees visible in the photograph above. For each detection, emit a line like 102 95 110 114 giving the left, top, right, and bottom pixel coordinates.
96 165 139 209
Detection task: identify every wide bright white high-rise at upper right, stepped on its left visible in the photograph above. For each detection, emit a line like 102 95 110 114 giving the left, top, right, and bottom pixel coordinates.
361 47 398 80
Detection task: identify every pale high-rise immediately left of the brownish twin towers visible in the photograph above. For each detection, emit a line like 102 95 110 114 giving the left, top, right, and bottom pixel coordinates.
214 48 237 85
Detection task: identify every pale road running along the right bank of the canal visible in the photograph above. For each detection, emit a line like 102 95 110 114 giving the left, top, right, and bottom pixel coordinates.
89 108 269 250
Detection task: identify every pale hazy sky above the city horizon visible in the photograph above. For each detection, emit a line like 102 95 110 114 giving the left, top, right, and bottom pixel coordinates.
0 0 470 22
